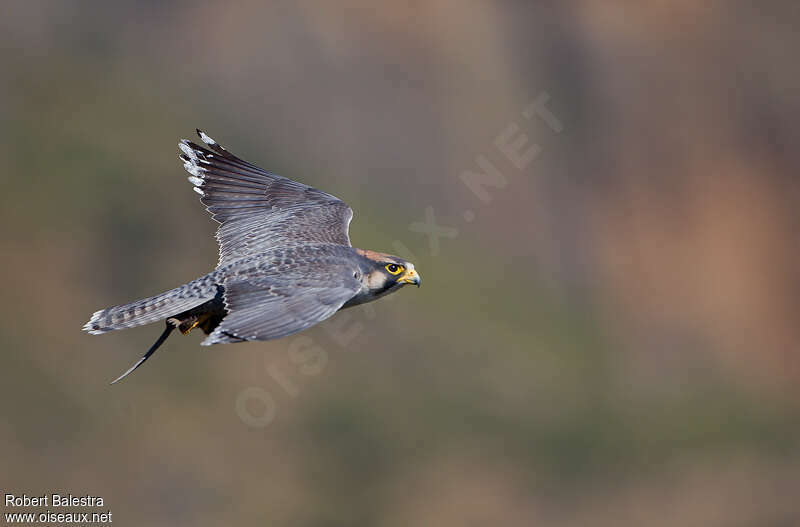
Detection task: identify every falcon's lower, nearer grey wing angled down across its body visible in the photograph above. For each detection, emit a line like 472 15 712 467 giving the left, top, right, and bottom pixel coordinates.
202 266 361 346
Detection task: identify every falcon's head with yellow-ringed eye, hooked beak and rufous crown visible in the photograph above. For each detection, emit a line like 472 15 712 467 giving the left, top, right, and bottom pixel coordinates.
348 249 422 305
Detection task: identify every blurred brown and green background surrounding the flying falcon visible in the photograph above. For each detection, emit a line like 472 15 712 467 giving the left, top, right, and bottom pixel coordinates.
0 0 800 527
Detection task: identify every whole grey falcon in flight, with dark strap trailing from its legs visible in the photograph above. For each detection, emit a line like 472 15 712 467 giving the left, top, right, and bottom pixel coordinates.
83 130 420 384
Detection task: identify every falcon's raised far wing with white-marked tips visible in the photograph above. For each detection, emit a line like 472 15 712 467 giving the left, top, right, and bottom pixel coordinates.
178 130 353 265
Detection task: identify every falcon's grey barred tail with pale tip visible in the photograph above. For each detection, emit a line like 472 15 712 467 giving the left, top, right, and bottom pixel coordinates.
83 275 217 335
